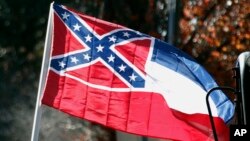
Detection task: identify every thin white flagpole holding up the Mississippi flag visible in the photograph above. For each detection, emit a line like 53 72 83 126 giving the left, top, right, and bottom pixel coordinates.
31 3 53 141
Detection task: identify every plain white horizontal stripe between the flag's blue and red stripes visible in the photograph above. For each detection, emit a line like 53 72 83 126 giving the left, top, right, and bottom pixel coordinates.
145 61 218 117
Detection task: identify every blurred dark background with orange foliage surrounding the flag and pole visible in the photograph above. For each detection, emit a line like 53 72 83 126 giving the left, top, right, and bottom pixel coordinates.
0 0 250 141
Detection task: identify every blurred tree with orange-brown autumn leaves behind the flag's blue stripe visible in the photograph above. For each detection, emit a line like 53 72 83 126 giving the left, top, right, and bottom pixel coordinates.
178 0 250 86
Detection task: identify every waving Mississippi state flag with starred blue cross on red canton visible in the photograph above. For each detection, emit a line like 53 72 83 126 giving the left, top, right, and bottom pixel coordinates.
42 4 234 141
